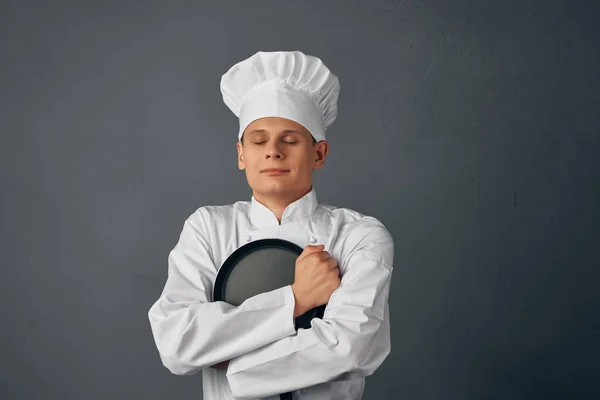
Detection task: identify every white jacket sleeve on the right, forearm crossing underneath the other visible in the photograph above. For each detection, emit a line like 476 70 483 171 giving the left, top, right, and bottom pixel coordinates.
226 218 394 400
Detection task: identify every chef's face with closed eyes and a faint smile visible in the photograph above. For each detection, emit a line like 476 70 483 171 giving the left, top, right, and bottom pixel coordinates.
237 117 327 196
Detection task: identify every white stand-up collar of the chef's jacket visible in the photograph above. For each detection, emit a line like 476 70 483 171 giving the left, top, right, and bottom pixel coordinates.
250 187 318 229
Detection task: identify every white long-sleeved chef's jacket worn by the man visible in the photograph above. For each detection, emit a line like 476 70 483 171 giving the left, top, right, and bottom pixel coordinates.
148 187 394 400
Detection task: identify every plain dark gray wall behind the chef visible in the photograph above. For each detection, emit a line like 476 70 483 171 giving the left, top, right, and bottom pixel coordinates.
0 0 600 400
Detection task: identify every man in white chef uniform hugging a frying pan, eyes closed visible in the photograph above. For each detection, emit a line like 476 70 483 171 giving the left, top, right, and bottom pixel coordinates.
148 51 394 400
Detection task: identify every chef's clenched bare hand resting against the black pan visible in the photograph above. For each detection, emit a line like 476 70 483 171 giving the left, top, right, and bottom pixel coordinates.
292 245 341 318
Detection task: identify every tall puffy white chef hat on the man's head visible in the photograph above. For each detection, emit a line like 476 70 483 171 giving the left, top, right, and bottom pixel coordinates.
221 51 340 142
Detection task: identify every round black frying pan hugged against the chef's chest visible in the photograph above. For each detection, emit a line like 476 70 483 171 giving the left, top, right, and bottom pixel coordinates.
213 239 326 400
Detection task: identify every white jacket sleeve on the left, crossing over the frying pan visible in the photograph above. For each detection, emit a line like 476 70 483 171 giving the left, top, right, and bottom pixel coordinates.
148 209 296 375
